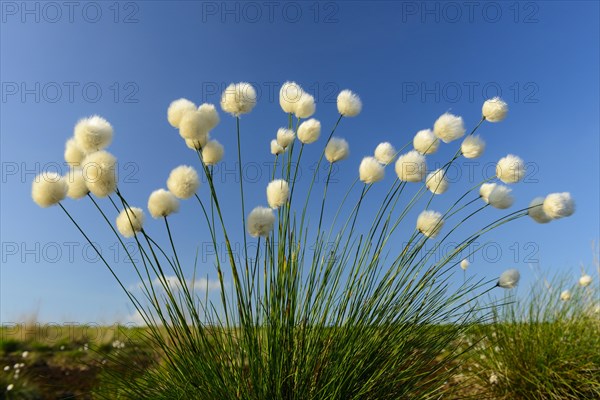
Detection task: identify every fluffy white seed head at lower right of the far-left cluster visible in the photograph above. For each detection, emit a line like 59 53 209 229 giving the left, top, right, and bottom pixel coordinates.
81 150 117 197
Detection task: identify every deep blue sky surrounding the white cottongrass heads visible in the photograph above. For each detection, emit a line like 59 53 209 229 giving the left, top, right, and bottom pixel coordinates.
0 1 600 323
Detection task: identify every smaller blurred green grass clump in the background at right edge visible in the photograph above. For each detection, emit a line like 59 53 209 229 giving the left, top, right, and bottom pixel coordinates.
467 264 600 400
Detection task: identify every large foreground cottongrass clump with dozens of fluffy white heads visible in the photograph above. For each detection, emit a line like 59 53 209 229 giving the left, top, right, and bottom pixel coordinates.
32 82 574 400
